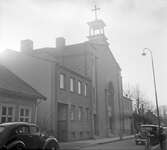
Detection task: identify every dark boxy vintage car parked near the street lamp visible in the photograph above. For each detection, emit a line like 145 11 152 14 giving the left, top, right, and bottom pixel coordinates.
135 124 162 145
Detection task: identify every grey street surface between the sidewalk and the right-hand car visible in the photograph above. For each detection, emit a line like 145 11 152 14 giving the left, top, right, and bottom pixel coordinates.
81 139 144 150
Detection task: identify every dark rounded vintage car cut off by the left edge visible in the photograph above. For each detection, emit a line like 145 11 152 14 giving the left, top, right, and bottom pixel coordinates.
0 122 59 150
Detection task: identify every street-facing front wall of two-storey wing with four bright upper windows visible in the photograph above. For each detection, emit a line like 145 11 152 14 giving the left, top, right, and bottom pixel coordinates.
56 65 92 141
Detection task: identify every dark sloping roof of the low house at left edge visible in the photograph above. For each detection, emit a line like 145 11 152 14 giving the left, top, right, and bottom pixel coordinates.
0 64 46 100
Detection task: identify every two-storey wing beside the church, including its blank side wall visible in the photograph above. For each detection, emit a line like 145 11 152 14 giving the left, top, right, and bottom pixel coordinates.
1 50 92 141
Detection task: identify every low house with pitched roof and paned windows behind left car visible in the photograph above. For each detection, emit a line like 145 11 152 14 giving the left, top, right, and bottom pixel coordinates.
0 64 46 123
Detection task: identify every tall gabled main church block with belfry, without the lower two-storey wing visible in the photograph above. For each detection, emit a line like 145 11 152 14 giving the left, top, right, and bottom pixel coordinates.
34 17 122 137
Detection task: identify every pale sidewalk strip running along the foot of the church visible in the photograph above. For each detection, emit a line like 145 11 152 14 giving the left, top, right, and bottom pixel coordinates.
60 135 134 150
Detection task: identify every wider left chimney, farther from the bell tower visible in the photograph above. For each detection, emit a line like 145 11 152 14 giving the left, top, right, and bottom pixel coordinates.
21 39 33 53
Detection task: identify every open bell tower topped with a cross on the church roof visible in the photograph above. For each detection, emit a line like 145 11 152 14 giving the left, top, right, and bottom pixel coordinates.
88 5 107 44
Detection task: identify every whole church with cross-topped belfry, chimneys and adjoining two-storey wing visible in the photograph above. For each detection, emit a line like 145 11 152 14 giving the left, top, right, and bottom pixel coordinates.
1 7 126 141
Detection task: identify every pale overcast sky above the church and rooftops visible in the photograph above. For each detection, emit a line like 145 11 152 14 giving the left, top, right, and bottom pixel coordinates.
0 0 167 105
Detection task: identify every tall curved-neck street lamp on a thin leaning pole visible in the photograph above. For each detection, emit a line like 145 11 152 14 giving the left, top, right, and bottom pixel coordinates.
142 48 160 133
